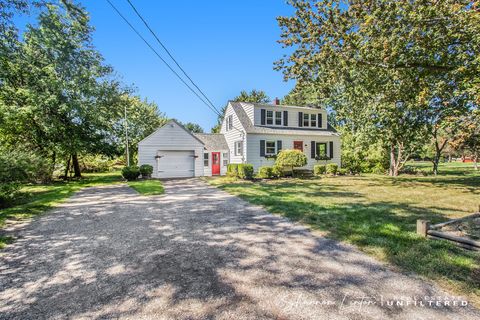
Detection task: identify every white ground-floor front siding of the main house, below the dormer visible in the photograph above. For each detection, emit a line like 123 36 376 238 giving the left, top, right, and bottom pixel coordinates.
247 134 341 171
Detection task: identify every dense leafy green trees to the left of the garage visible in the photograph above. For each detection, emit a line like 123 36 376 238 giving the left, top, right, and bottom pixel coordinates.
0 0 165 180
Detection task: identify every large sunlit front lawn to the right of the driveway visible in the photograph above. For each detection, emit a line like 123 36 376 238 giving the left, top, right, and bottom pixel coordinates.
208 163 480 305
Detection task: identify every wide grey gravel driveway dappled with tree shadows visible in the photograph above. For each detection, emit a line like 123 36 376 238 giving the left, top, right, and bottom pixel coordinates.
0 179 480 320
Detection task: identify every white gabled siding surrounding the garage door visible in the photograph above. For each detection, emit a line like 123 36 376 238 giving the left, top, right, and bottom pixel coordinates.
138 121 204 178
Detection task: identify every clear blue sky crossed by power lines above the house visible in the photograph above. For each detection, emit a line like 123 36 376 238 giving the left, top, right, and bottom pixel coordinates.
82 0 294 131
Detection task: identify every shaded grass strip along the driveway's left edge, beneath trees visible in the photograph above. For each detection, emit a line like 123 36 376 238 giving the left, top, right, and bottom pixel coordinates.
0 171 122 248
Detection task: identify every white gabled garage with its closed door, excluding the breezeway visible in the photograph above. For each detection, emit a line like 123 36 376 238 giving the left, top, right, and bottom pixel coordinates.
138 120 205 178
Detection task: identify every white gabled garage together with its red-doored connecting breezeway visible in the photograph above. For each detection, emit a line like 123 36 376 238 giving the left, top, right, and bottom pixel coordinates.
138 120 229 178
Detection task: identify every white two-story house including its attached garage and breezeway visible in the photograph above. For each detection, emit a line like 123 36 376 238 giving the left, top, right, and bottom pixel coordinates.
138 102 341 178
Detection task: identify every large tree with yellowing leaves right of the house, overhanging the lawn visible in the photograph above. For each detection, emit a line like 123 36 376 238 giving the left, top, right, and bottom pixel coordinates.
276 0 480 175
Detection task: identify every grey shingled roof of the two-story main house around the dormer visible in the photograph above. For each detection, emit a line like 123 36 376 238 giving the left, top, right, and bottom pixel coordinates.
230 102 339 136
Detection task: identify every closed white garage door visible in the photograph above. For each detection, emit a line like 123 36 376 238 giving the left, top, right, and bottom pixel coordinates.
157 150 195 178
